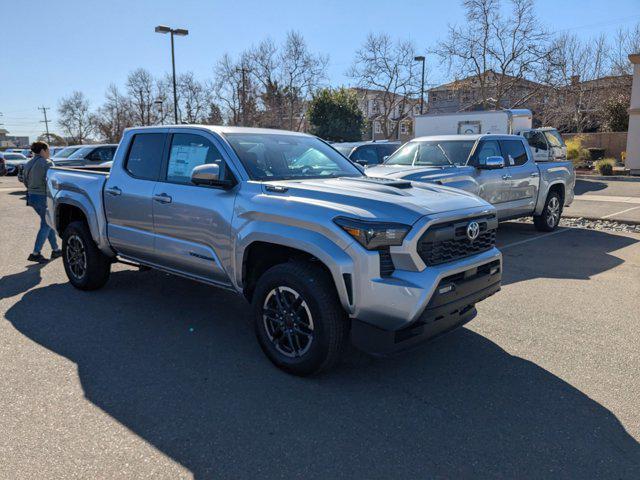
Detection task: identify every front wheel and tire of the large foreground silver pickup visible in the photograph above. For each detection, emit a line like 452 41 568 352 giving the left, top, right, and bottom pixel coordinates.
252 262 350 376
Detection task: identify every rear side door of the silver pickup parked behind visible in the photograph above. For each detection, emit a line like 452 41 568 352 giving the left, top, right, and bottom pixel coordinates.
500 138 540 216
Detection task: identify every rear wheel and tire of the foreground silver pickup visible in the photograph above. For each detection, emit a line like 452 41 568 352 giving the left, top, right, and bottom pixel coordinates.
62 222 111 290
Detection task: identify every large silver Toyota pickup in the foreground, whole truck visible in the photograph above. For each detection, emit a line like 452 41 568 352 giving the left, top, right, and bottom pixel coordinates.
47 126 502 375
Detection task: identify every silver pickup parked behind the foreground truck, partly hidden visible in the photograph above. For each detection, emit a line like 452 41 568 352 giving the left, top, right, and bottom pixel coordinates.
366 135 576 231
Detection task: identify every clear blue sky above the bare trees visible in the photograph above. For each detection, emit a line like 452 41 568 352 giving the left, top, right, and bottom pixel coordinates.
0 0 640 136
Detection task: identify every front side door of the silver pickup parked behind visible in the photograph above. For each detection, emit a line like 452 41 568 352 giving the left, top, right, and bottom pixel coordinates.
469 140 510 217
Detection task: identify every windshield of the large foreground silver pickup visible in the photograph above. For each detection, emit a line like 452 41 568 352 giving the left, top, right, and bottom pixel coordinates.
225 133 362 180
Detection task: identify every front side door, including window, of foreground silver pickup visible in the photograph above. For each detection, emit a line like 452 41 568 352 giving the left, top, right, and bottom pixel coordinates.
153 133 236 285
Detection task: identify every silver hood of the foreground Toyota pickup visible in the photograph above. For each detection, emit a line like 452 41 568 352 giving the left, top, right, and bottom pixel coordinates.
263 177 493 225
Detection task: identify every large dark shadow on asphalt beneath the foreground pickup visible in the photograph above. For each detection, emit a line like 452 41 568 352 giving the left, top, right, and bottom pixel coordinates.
6 270 640 478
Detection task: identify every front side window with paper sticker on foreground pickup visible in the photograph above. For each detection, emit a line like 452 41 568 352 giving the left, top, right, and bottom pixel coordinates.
167 133 227 183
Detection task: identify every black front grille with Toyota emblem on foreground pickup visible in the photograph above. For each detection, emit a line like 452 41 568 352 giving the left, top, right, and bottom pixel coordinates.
418 217 498 265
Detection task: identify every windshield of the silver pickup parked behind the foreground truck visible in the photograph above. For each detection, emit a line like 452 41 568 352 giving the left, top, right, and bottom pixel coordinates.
384 140 475 167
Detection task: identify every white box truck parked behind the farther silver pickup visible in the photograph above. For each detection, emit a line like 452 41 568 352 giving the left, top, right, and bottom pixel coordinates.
415 109 567 162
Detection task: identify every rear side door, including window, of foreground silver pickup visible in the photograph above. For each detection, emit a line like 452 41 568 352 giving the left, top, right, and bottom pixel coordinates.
104 132 167 263
